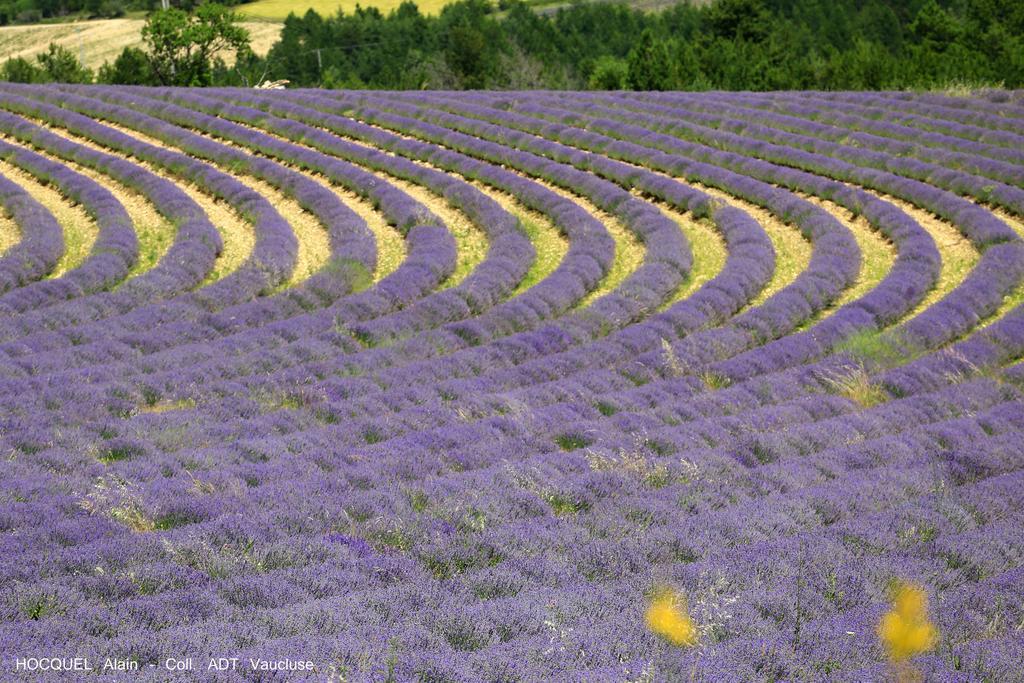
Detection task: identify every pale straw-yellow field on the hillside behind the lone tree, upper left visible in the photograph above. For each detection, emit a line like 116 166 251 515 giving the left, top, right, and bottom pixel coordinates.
0 18 280 70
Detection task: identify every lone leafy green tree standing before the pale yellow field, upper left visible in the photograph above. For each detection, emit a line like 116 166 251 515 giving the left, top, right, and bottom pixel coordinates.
142 2 249 86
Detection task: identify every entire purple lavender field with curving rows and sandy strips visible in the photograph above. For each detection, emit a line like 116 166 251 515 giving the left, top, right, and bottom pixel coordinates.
0 84 1024 683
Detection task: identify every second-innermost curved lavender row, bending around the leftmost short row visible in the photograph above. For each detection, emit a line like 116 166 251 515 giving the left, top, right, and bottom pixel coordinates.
0 129 138 313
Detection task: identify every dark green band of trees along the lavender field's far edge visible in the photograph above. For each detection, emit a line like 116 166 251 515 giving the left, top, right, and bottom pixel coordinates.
0 0 1024 90
